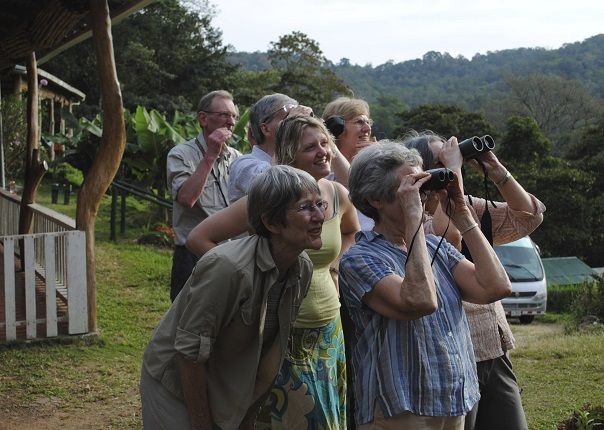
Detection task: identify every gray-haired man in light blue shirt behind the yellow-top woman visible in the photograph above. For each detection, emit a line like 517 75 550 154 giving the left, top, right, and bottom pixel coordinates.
229 93 312 203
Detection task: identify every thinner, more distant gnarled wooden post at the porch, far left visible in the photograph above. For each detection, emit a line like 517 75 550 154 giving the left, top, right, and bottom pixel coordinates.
19 52 48 239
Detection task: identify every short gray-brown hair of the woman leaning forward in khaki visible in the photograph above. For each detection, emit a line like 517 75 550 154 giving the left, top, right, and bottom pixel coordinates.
247 166 320 237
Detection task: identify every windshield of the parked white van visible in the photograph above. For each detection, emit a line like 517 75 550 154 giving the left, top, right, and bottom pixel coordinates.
495 245 543 282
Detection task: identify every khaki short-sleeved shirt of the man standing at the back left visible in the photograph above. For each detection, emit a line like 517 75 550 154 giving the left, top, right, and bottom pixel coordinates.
166 133 241 245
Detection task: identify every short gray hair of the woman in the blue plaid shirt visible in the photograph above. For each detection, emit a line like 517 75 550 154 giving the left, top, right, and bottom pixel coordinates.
348 140 422 221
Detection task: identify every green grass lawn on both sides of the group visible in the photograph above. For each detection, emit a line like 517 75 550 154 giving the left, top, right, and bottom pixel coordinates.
0 184 604 430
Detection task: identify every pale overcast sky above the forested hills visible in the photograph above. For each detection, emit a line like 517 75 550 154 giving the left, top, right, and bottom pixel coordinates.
212 0 604 66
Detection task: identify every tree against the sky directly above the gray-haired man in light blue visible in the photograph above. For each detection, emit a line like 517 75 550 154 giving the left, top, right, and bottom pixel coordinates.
268 31 351 112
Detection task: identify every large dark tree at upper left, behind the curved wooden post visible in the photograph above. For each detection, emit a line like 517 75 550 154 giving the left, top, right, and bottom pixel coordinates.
45 0 238 115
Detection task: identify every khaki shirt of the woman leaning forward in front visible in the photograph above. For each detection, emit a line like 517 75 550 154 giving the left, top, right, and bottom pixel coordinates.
143 236 312 429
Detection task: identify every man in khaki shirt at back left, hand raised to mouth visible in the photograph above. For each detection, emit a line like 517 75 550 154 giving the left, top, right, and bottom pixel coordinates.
166 90 241 301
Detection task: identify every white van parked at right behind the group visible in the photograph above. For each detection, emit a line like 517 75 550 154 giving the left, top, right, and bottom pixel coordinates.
495 236 547 324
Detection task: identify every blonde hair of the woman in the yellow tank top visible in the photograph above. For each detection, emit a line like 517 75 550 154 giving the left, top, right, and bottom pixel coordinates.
275 116 335 166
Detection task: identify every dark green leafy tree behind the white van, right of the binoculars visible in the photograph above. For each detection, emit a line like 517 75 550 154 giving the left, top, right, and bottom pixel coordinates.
497 117 602 268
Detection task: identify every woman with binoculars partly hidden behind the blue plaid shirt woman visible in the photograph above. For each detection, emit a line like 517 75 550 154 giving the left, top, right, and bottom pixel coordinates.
403 132 545 430
